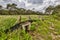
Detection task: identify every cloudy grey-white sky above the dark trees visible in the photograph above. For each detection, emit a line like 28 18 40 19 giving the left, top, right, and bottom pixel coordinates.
0 0 60 12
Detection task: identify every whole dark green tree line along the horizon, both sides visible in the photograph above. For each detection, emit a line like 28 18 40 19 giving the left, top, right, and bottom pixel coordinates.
0 3 60 15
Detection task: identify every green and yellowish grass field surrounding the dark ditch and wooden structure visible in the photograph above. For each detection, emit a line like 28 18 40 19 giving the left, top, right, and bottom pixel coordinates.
0 15 60 40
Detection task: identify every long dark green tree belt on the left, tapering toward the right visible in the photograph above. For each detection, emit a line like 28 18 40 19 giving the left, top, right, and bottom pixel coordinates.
0 3 42 15
